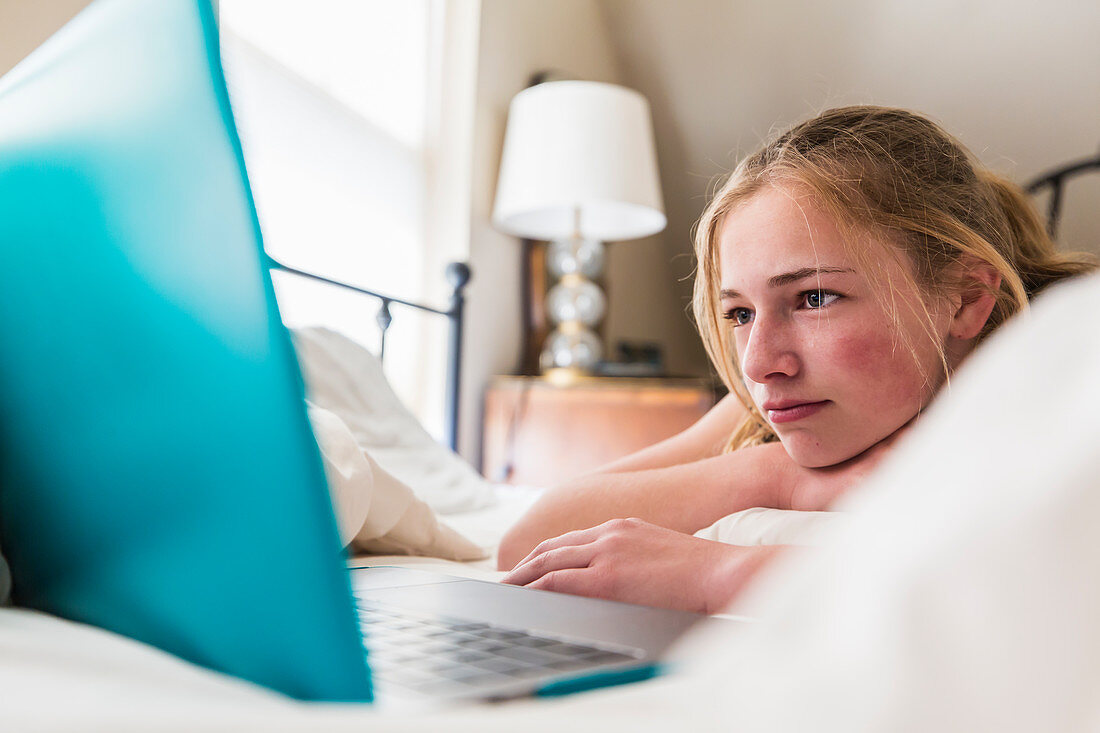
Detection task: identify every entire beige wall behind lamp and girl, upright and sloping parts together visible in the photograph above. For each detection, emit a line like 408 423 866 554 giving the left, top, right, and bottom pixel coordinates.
468 0 1100 394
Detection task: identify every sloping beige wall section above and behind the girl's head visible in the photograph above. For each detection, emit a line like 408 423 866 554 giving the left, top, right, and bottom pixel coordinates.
594 0 1100 371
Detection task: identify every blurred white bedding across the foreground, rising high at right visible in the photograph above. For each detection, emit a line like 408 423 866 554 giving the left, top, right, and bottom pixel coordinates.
0 277 1100 733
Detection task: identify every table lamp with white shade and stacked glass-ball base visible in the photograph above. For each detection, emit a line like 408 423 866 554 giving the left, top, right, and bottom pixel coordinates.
493 81 666 375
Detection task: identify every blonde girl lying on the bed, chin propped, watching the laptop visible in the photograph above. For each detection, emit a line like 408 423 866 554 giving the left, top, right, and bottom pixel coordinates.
498 107 1093 612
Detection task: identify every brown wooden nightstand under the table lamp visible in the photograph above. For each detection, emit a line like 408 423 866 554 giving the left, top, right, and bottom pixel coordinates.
482 376 715 486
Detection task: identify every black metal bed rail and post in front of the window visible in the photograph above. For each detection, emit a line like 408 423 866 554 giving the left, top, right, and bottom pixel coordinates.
267 256 470 451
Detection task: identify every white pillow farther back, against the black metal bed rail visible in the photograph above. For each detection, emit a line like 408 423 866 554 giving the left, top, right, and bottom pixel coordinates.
292 328 495 514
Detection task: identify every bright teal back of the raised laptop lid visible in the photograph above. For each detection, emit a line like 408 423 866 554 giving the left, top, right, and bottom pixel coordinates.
0 0 370 700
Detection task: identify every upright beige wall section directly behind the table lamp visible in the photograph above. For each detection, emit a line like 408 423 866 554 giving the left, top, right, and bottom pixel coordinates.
463 0 702 456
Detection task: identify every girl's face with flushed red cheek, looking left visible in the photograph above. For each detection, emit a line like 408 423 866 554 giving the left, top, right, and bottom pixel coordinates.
719 187 950 467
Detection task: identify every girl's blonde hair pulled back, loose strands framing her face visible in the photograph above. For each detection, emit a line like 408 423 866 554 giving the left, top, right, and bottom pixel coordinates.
693 106 1096 450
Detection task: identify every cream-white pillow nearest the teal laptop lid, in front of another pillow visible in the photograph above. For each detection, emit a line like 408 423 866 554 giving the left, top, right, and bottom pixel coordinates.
307 403 486 560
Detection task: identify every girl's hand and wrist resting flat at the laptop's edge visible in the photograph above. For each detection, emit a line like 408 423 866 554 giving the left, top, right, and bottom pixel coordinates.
504 519 781 613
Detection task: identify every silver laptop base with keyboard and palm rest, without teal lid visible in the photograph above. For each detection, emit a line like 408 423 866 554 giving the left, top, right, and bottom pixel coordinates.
352 567 700 698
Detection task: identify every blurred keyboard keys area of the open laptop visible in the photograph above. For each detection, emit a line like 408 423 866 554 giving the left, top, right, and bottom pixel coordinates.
355 598 642 694
